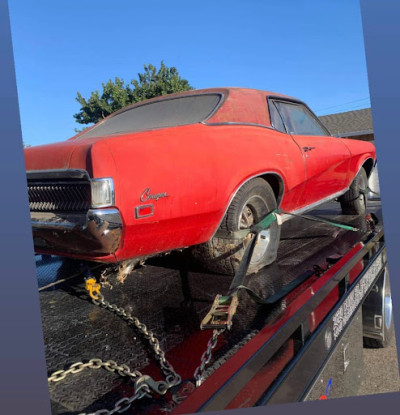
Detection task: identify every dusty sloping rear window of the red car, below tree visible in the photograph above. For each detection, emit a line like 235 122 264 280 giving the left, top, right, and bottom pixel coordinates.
78 94 222 139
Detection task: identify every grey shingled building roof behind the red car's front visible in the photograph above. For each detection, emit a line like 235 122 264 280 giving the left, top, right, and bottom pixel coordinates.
319 108 373 137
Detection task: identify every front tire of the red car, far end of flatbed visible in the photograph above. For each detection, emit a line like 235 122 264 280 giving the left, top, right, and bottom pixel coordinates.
339 167 368 215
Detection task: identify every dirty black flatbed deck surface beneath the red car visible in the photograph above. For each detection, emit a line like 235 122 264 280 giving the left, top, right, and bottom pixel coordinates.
37 201 382 415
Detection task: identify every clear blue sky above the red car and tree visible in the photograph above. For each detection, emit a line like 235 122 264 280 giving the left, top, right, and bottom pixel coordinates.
9 0 370 145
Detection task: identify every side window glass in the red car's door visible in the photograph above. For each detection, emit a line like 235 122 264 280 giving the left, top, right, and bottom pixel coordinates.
275 101 329 136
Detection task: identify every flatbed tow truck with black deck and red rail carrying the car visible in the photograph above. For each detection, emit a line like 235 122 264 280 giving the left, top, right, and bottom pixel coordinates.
37 201 393 415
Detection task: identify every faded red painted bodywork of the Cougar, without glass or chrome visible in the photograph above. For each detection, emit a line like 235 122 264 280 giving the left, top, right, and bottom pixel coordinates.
25 88 375 261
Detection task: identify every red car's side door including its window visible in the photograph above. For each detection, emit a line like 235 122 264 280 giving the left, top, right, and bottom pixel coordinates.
274 100 350 210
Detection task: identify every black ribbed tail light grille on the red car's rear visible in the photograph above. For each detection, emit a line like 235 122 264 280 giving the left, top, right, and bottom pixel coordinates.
28 182 91 212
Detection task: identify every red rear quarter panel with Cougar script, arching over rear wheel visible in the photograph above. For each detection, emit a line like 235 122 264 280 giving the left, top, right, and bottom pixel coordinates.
105 124 305 259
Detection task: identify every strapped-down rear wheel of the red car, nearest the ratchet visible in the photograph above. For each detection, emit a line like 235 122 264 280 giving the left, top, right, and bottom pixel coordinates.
192 178 280 275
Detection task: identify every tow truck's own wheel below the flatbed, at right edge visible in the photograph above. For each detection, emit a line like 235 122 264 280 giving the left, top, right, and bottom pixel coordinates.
363 267 394 348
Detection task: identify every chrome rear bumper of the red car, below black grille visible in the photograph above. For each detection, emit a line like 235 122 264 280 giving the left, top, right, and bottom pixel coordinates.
31 209 123 256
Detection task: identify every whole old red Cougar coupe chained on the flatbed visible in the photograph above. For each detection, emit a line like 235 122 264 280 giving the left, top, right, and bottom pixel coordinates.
25 88 376 274
